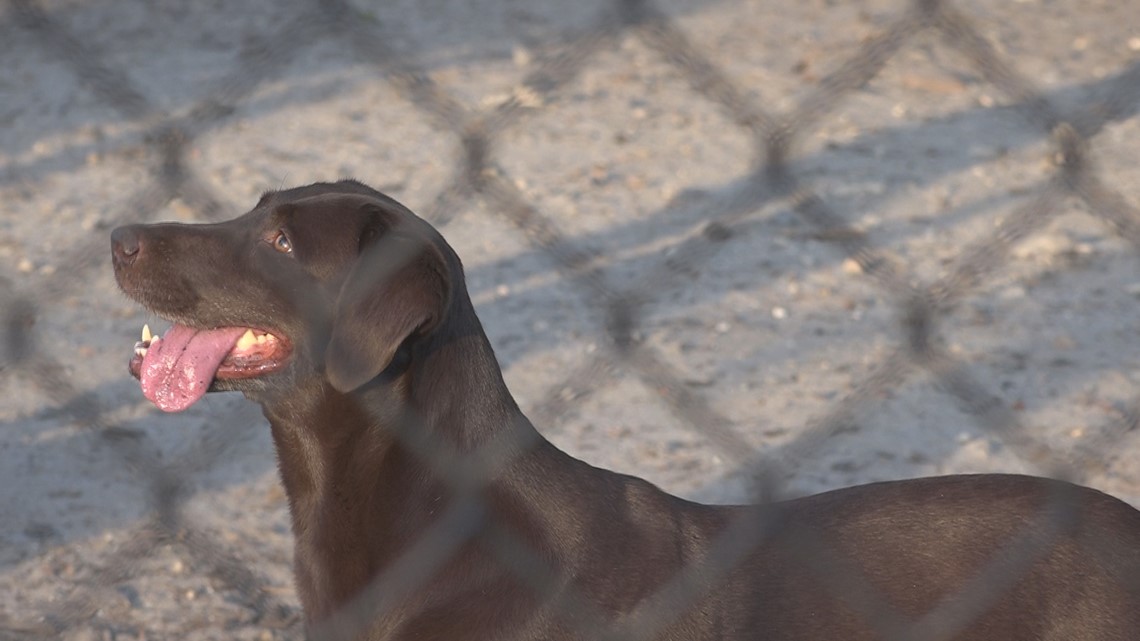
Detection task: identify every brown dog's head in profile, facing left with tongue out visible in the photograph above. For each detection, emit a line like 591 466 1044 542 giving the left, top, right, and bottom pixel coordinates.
112 180 462 412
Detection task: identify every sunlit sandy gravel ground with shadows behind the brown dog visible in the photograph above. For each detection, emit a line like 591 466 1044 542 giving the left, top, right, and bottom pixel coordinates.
0 0 1140 640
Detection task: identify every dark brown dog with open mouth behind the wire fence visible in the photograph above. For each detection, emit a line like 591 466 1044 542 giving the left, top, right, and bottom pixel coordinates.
112 181 1140 641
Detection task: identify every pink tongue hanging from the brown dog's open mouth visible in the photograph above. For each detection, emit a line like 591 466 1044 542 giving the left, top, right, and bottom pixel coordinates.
139 324 245 412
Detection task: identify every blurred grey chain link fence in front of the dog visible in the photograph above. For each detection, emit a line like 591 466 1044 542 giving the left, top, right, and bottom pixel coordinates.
0 0 1140 639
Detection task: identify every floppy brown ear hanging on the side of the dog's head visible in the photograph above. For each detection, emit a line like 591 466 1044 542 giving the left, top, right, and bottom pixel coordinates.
325 232 449 393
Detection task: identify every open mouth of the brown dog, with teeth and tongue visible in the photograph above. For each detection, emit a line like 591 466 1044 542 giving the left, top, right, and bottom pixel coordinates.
129 323 293 412
